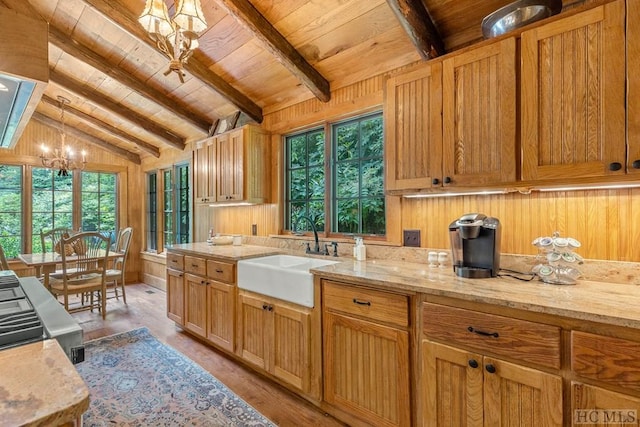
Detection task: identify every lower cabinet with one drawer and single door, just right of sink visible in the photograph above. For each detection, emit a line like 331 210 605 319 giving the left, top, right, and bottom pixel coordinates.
322 281 412 426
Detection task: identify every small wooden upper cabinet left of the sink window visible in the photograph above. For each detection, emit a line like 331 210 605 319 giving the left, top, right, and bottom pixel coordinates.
193 125 271 204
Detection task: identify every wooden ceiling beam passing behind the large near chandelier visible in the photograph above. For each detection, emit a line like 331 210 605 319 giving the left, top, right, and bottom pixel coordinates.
84 0 263 123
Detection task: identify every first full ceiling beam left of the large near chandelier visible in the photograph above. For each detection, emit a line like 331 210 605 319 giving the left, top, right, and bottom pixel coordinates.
49 25 211 134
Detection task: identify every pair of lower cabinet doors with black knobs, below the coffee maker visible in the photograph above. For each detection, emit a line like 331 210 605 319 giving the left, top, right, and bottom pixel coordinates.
422 340 562 427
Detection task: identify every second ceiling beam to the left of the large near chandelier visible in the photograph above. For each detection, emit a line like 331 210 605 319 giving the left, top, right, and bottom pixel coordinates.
49 70 186 150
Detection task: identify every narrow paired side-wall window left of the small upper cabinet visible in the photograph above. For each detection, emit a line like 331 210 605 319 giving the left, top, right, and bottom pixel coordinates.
147 164 191 251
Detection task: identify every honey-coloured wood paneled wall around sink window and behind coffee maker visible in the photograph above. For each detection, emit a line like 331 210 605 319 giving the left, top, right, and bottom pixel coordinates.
210 69 640 262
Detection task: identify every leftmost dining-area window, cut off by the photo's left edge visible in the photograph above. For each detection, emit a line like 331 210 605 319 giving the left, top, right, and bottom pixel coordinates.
0 165 23 258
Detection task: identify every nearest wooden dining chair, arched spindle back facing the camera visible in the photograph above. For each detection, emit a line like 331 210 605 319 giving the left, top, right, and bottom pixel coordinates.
50 232 111 319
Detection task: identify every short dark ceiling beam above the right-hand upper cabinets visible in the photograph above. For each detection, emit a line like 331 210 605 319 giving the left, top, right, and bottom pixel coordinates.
387 0 445 59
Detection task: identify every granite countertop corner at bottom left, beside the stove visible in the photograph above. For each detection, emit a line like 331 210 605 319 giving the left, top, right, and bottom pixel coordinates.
0 340 89 426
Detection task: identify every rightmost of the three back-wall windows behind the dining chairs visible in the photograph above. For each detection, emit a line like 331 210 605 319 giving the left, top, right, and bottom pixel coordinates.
80 172 118 243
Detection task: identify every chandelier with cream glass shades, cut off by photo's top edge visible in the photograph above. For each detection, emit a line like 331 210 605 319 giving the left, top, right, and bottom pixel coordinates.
138 0 207 83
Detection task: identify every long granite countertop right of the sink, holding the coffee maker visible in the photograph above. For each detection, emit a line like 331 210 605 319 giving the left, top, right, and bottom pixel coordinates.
312 260 640 329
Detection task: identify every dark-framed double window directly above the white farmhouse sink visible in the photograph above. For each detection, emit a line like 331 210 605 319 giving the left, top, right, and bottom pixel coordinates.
285 113 386 236
